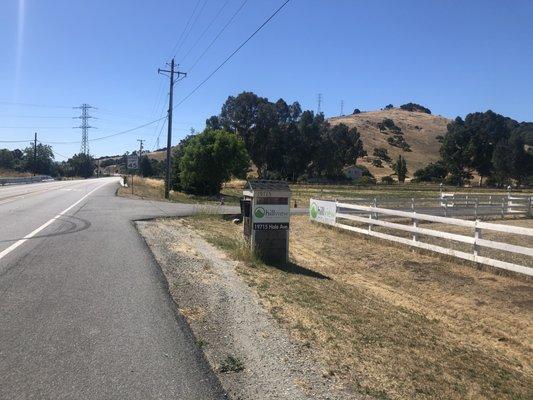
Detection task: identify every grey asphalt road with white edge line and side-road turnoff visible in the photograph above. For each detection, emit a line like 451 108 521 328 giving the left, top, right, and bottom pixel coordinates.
0 178 233 400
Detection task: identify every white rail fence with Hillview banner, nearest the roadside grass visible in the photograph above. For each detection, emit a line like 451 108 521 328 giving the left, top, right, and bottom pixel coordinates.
309 199 533 276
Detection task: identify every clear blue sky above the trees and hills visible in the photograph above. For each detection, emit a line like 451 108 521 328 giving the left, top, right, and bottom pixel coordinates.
0 0 533 161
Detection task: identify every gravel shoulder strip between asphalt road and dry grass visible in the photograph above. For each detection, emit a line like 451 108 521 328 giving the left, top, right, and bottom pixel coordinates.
137 220 360 400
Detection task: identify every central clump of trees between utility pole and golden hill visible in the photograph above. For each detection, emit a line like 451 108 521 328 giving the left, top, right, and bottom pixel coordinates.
172 92 366 194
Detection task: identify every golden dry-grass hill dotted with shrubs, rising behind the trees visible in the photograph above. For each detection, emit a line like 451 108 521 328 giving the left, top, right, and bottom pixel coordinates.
329 108 451 177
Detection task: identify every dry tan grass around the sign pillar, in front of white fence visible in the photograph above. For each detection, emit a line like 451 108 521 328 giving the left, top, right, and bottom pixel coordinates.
190 217 533 399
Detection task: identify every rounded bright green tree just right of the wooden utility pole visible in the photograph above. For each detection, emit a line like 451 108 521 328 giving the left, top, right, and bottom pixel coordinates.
179 130 250 195
